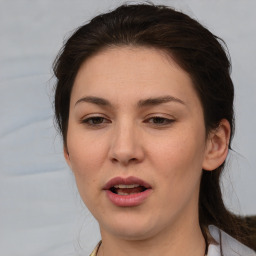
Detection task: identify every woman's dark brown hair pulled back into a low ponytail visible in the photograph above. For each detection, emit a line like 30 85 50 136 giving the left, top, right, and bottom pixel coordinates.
54 4 253 252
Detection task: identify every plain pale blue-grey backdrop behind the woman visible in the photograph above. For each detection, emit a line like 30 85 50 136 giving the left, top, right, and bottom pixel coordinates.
0 0 256 256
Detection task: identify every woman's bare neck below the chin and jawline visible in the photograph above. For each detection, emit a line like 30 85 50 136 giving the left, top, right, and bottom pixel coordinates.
98 220 206 256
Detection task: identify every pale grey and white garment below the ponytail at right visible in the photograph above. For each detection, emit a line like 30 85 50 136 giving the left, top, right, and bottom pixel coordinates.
208 225 256 256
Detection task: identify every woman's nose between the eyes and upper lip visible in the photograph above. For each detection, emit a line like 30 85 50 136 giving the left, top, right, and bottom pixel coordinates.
109 122 144 166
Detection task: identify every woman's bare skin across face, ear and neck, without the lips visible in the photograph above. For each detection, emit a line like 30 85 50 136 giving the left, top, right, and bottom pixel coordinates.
64 46 230 256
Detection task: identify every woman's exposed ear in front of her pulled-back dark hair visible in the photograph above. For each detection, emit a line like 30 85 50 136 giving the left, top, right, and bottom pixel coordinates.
202 119 230 171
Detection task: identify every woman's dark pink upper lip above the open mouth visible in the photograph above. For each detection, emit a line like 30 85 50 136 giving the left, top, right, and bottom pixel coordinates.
103 176 151 190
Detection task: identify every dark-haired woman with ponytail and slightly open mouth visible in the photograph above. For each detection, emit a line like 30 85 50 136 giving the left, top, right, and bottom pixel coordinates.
54 4 255 256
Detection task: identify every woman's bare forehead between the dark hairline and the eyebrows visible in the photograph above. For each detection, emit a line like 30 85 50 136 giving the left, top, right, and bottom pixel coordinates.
71 46 198 108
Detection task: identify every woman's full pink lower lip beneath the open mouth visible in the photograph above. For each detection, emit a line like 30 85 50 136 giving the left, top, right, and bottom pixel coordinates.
105 189 152 207
